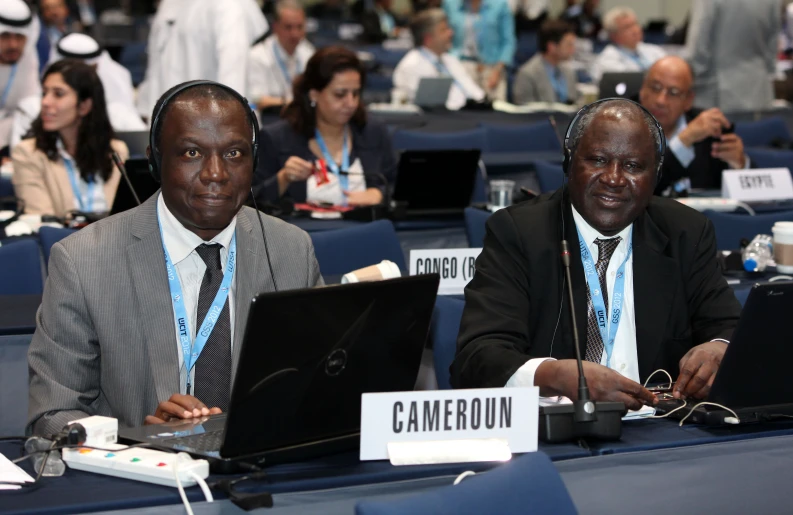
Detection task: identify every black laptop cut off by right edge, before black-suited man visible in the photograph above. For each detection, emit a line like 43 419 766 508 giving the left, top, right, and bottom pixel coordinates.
657 281 793 425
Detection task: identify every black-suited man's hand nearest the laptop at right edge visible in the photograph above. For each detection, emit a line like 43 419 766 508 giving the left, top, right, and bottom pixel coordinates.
672 342 727 399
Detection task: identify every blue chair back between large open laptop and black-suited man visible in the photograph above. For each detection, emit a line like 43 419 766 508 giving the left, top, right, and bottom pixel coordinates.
430 295 465 390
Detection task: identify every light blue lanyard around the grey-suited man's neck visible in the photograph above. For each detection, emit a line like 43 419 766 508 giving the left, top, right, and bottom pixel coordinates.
157 206 237 395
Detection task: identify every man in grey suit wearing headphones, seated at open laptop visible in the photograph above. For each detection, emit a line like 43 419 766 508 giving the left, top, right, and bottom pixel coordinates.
28 84 322 436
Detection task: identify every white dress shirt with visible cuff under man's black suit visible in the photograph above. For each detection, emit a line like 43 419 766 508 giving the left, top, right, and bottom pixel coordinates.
506 207 639 387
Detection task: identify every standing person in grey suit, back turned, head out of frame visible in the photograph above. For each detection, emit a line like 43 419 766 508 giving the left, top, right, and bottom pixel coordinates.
686 0 782 112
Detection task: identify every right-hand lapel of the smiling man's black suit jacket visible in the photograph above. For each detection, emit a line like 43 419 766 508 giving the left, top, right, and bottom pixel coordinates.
633 212 677 378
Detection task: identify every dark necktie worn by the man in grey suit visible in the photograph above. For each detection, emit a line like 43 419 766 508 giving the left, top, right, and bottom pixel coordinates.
195 244 231 411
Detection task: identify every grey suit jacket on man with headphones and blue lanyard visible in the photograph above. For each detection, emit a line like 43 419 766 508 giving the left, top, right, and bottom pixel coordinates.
27 195 322 436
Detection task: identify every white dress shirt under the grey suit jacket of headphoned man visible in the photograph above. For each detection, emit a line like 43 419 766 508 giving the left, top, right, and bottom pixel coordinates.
157 193 237 394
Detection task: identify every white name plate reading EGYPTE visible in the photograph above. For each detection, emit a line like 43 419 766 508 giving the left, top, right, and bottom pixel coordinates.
721 168 793 202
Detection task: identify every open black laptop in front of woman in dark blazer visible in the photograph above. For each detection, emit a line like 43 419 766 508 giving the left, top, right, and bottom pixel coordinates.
392 150 481 217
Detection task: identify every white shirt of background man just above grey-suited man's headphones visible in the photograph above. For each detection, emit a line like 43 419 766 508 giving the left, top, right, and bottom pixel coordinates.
247 34 315 102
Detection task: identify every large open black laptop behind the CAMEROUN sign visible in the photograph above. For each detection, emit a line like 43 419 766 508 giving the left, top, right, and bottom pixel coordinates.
119 274 439 472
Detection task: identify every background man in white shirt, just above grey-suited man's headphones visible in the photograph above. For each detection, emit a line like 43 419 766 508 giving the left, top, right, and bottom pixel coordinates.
248 0 314 109
